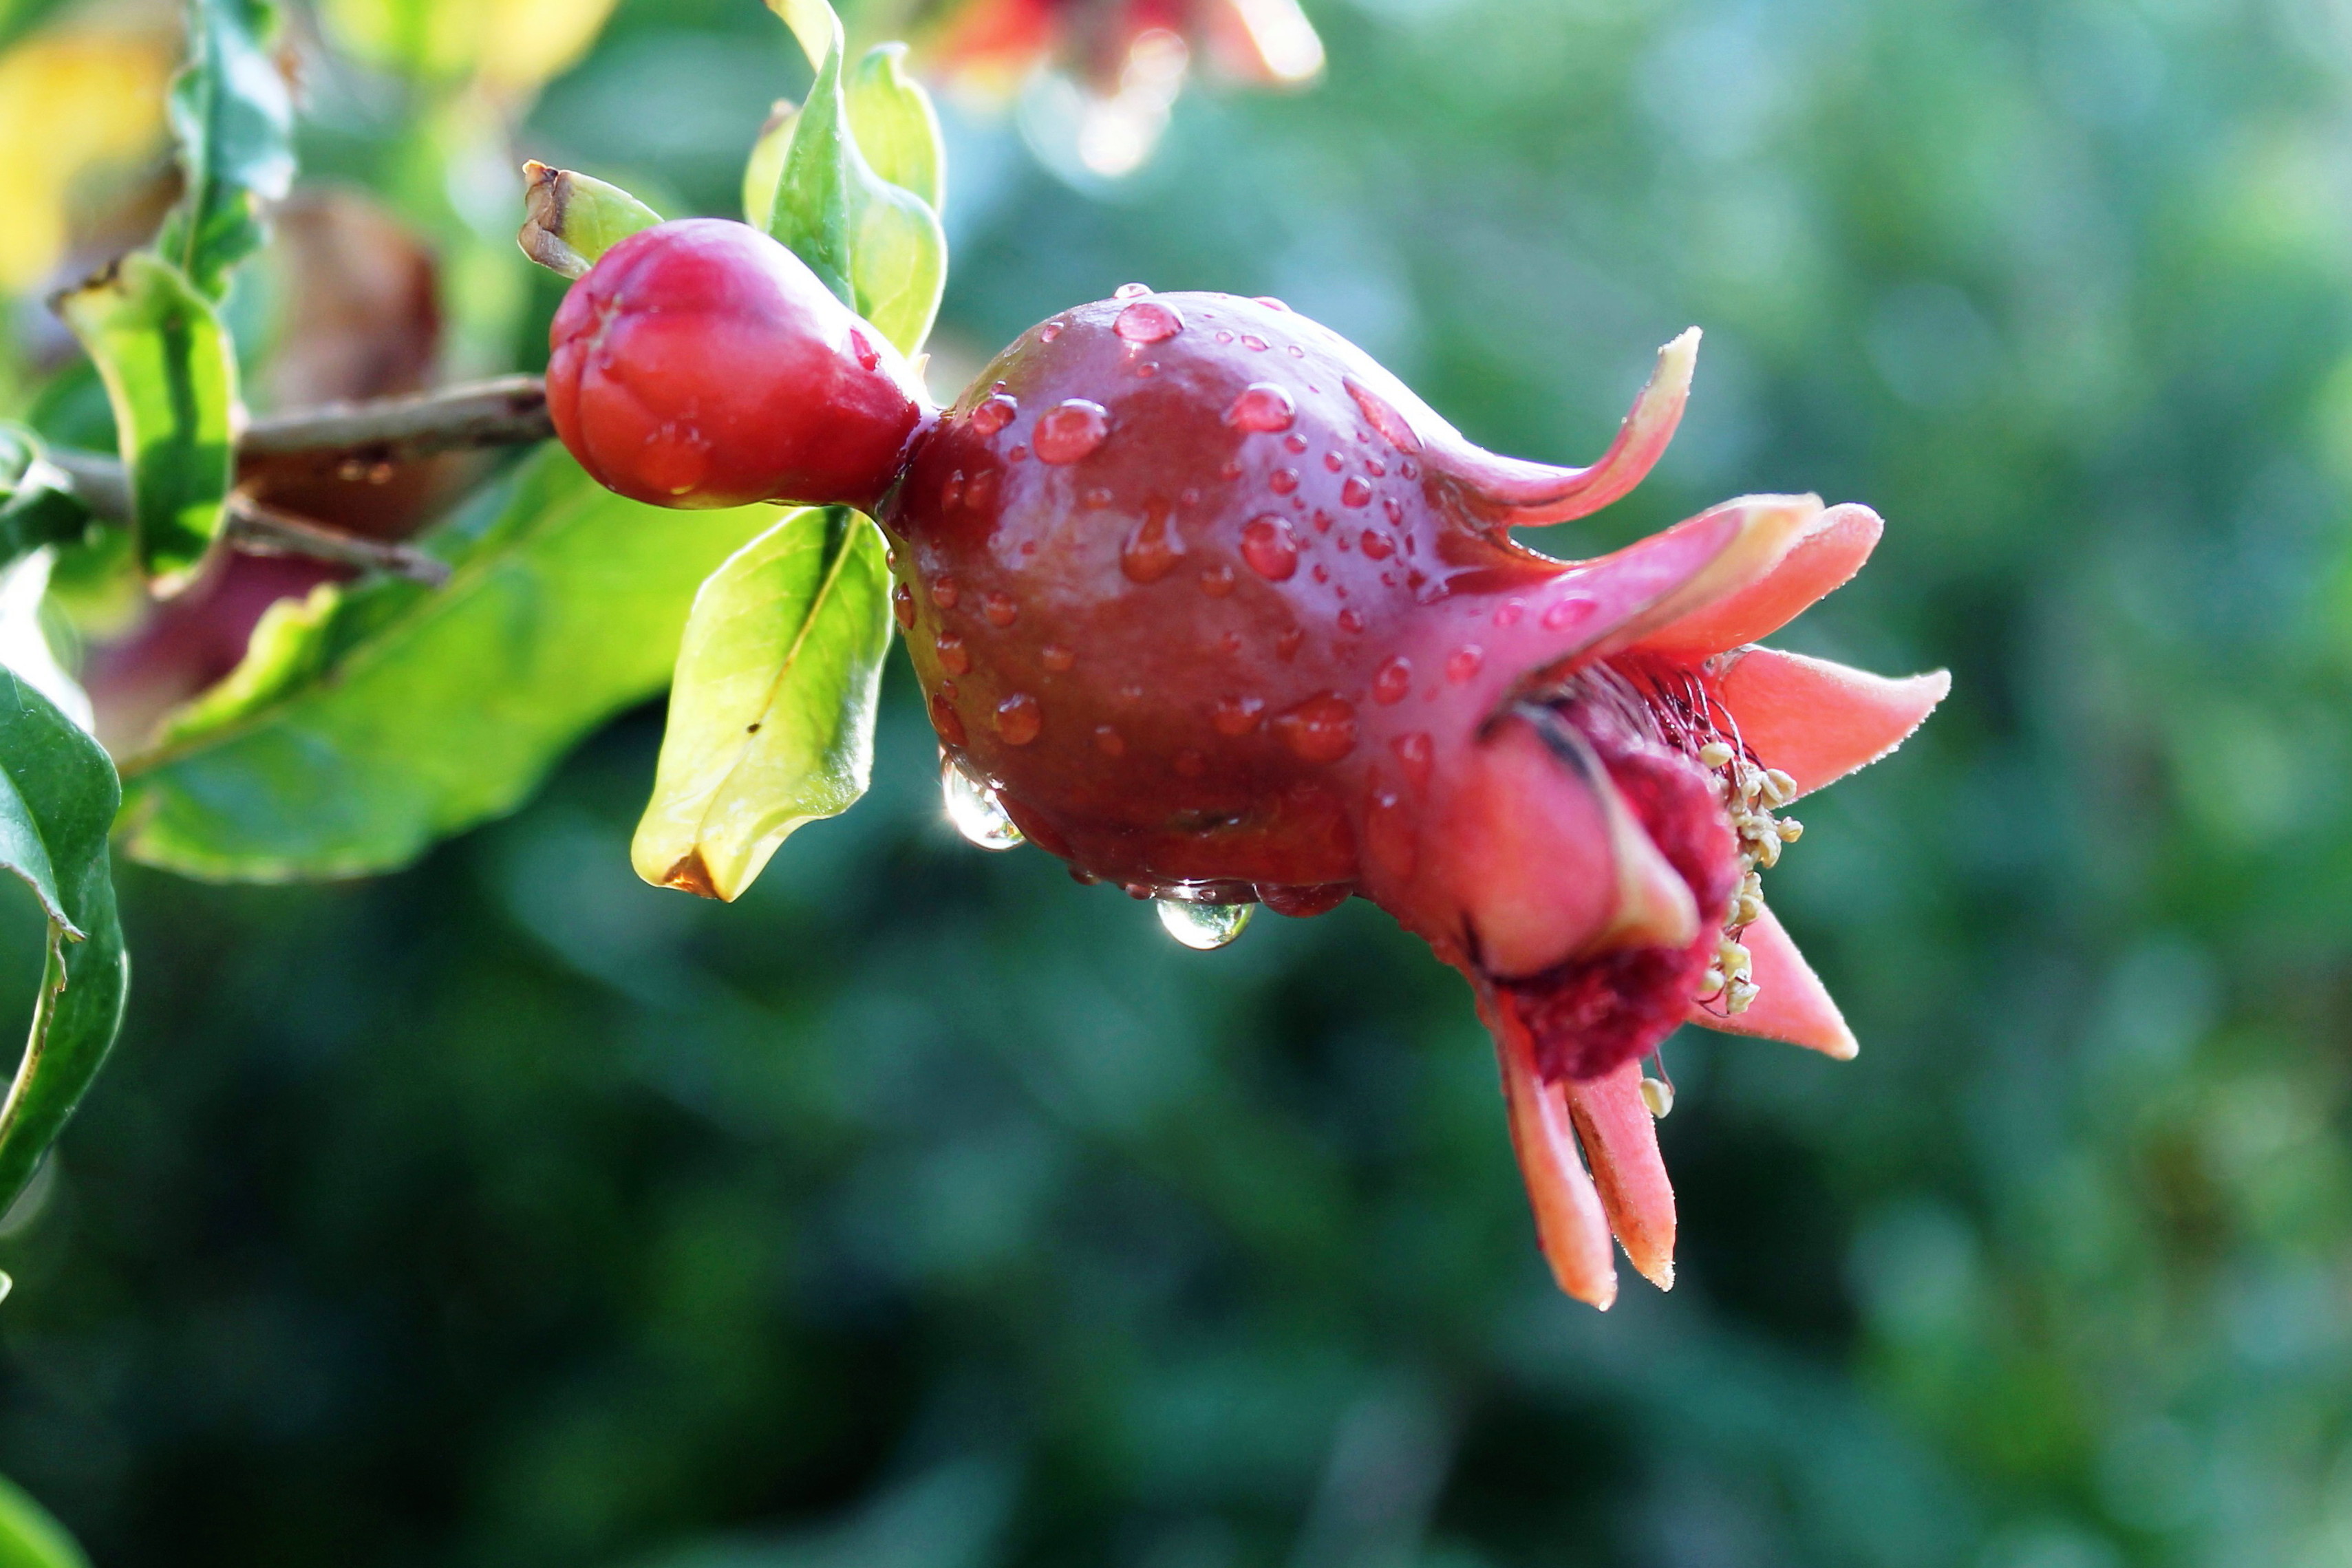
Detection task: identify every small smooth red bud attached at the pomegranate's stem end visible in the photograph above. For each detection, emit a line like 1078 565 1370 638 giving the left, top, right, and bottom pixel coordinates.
548 219 924 510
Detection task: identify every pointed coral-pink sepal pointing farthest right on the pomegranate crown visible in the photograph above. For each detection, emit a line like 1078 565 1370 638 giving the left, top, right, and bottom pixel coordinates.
1700 649 1952 795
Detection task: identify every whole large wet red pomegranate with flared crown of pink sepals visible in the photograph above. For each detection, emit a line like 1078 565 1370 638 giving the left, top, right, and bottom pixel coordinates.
884 288 1947 1304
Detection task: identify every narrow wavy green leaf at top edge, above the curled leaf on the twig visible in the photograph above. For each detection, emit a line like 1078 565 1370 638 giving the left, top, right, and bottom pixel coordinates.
156 0 294 299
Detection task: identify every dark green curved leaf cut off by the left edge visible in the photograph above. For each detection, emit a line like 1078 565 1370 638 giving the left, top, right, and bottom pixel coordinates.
0 670 129 1211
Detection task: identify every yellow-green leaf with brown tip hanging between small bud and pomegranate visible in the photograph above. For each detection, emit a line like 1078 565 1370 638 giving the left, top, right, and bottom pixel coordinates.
628 506 889 901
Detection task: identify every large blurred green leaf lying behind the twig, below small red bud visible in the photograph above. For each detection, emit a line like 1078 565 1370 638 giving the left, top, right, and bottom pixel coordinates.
122 444 776 881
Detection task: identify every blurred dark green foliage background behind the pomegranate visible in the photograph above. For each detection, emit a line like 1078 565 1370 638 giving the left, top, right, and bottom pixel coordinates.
0 0 2352 1568
